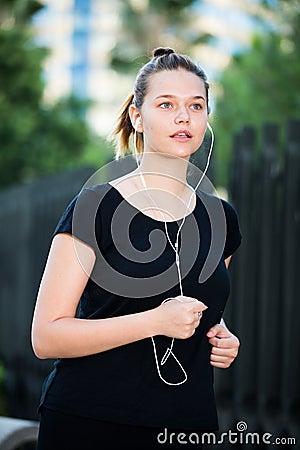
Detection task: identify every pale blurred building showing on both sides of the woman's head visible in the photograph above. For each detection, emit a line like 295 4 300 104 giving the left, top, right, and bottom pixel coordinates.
34 0 268 135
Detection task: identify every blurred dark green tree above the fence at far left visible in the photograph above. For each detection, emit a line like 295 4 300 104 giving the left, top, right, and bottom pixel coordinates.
0 0 100 188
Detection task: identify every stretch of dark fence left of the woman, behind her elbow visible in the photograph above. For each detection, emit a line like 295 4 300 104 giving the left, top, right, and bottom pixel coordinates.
0 168 92 419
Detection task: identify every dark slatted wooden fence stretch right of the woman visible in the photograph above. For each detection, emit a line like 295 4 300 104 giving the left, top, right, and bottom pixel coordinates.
216 120 300 448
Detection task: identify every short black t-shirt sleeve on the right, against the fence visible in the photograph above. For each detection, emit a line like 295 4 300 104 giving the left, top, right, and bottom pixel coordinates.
222 200 242 259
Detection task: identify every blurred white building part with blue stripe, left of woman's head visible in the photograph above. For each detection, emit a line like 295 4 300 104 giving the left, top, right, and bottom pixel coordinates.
34 0 132 135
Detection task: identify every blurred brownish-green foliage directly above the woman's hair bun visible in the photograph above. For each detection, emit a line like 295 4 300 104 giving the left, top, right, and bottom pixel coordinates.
110 0 213 72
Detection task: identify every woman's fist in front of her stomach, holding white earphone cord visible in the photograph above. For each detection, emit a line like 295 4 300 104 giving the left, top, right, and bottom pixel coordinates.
155 295 207 339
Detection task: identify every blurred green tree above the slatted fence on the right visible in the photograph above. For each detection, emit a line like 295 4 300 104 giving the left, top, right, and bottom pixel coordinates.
212 0 300 186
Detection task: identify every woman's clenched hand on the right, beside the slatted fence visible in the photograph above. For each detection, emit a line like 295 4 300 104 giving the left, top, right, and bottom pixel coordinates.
206 323 240 369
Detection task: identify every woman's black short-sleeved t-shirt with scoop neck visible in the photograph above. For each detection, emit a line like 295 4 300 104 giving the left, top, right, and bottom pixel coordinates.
41 183 241 430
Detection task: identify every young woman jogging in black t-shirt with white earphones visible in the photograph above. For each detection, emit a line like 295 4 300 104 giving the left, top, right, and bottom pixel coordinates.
32 48 241 450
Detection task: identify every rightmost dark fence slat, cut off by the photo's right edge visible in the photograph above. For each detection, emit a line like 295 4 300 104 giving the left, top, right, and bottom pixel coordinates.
280 120 300 440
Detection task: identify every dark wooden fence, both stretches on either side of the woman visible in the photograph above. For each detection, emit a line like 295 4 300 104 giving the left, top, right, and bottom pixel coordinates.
0 120 300 448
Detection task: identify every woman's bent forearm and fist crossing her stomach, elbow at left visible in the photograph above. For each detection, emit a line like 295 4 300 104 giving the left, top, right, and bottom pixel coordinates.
32 296 207 359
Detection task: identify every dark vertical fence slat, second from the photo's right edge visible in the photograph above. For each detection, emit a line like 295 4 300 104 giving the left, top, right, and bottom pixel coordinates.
256 124 281 432
